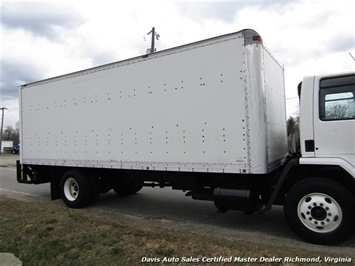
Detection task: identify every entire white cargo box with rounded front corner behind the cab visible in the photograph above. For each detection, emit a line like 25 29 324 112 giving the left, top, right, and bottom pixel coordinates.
20 30 287 174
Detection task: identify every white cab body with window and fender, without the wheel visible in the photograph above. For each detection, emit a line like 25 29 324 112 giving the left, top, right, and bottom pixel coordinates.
300 73 355 177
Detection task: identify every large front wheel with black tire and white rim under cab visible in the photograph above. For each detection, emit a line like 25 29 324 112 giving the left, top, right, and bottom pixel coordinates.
284 178 355 245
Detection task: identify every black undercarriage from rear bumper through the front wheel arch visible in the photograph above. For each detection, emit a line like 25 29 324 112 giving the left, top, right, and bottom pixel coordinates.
17 158 355 210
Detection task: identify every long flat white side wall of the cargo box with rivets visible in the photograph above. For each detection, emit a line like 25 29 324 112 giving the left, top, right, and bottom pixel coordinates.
22 38 248 175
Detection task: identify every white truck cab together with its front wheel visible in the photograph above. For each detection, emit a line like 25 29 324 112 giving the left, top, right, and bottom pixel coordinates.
283 73 355 245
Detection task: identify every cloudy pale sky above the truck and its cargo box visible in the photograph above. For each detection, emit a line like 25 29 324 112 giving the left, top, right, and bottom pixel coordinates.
0 0 355 127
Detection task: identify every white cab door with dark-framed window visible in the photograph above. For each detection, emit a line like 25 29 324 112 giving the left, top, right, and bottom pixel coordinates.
314 73 355 166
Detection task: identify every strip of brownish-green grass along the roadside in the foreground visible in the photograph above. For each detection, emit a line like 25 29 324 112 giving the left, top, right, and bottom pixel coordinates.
0 197 350 266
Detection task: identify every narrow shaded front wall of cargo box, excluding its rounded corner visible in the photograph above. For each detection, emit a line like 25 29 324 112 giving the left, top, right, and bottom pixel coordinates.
263 49 287 171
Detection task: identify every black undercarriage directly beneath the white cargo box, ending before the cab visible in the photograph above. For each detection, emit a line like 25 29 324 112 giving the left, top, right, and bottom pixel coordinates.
17 161 280 213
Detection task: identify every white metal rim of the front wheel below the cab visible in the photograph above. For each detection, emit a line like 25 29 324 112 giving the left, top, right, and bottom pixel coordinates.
297 193 342 233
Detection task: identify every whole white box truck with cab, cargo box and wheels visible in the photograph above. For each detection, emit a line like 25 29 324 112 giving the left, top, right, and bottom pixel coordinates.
17 29 355 244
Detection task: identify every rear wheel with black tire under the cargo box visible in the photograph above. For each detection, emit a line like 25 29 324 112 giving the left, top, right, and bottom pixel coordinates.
60 170 91 208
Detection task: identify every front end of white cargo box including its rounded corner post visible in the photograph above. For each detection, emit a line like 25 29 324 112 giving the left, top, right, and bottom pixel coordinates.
245 43 287 174
